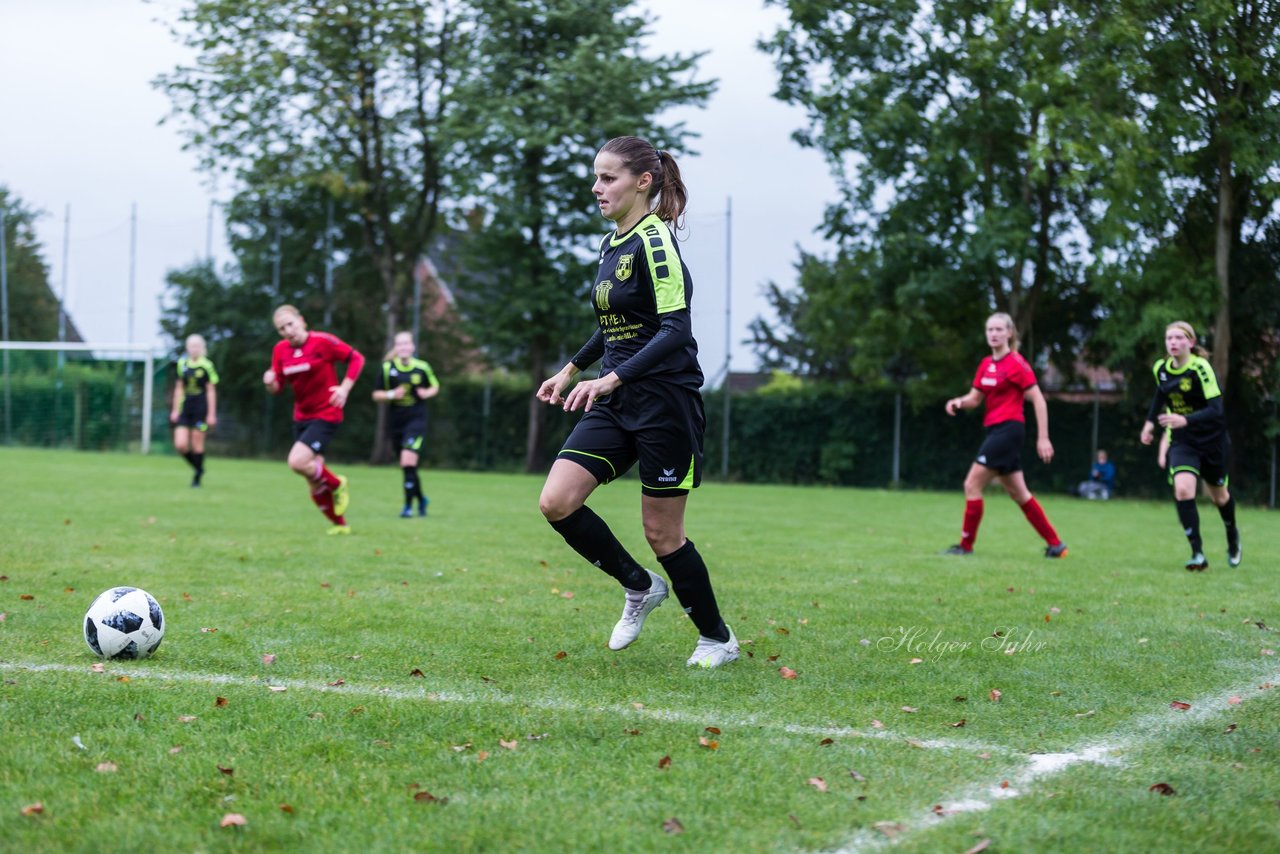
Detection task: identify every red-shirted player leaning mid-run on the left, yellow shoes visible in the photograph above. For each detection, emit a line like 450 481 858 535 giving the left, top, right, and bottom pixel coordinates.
262 306 365 534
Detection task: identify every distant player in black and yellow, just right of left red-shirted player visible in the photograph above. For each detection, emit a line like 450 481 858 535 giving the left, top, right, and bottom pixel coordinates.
374 332 440 519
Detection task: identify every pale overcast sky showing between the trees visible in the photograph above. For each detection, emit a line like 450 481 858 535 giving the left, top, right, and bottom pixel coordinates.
0 0 833 378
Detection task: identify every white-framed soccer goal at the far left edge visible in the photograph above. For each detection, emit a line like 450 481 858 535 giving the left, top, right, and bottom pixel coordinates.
0 341 168 453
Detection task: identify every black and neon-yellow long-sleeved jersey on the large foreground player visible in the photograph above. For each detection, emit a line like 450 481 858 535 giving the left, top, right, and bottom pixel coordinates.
573 214 703 389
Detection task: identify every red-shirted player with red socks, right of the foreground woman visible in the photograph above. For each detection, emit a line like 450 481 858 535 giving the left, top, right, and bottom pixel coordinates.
943 311 1066 557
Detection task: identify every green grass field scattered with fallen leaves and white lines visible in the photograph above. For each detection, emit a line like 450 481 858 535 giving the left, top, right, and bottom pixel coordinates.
0 449 1280 853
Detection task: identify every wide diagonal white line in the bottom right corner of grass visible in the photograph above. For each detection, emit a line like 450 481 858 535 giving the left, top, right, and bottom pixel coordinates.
819 668 1280 854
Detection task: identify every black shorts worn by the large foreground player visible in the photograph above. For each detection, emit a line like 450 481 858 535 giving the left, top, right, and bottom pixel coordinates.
558 380 707 497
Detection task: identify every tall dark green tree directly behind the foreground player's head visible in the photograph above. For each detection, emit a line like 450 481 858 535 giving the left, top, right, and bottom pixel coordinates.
457 0 713 471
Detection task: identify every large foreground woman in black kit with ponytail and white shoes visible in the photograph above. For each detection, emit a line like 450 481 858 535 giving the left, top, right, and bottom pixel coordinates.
538 137 739 667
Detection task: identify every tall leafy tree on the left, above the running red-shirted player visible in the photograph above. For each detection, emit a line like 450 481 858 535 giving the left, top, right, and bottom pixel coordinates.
157 0 471 350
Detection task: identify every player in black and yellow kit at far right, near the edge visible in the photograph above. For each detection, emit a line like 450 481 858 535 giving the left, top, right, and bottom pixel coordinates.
1140 320 1243 572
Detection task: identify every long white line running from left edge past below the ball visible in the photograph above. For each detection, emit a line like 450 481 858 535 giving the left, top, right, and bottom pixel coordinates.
0 662 1018 755
